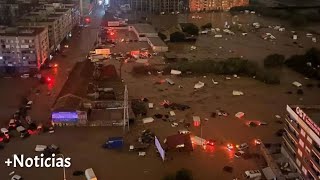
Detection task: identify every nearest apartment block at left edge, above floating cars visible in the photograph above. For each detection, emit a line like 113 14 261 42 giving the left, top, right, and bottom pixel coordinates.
0 27 49 73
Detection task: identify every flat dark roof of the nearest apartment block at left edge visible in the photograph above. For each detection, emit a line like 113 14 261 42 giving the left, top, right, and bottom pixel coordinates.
0 27 45 36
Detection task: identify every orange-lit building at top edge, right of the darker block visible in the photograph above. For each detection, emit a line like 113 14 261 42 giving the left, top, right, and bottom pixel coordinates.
189 0 249 12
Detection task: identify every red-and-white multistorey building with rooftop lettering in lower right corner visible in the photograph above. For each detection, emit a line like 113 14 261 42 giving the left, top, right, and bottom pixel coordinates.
281 105 320 180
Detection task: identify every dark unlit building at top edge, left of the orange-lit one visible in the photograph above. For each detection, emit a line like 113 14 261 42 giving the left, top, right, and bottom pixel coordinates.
128 0 185 13
